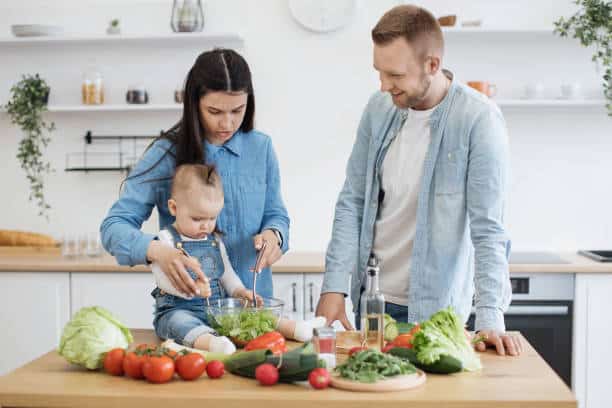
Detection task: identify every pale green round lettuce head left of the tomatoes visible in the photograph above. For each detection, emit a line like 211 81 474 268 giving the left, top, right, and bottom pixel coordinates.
58 306 134 370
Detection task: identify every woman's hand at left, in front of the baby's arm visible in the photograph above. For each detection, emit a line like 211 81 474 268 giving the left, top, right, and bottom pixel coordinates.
147 241 210 297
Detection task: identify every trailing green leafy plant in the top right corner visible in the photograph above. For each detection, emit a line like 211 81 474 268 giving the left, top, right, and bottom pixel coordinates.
555 0 612 116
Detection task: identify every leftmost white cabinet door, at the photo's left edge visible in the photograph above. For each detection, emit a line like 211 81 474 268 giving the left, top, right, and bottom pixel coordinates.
0 272 70 375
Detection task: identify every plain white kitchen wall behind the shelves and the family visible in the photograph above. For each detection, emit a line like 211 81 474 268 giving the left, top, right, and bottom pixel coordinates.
0 0 612 251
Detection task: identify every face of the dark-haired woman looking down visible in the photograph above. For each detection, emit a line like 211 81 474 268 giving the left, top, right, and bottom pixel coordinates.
200 92 248 145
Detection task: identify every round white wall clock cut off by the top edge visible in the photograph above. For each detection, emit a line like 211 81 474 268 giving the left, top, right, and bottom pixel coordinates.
289 0 358 33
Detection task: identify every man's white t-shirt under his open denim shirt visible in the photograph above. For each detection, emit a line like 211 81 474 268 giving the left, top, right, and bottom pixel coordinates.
372 107 435 306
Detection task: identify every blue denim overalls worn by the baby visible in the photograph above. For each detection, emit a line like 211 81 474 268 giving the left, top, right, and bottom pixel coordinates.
151 225 226 347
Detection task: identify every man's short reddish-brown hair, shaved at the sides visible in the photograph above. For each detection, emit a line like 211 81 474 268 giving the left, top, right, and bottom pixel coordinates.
372 5 444 57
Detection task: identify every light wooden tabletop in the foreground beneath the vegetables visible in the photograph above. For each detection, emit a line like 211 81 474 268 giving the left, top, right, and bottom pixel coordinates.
0 330 576 408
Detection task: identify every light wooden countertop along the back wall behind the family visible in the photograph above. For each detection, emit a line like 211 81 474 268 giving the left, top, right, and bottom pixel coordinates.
0 252 612 273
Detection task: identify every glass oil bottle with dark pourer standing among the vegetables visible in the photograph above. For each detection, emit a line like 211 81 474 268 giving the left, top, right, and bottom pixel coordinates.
360 253 385 350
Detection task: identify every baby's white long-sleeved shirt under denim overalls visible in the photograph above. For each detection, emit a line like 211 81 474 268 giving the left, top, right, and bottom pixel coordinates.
151 230 244 299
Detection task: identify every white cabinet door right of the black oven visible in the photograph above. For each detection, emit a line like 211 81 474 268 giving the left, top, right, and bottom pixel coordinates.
573 274 612 408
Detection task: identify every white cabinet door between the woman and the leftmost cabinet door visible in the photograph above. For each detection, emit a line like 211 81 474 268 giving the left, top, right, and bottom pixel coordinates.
71 273 155 329
